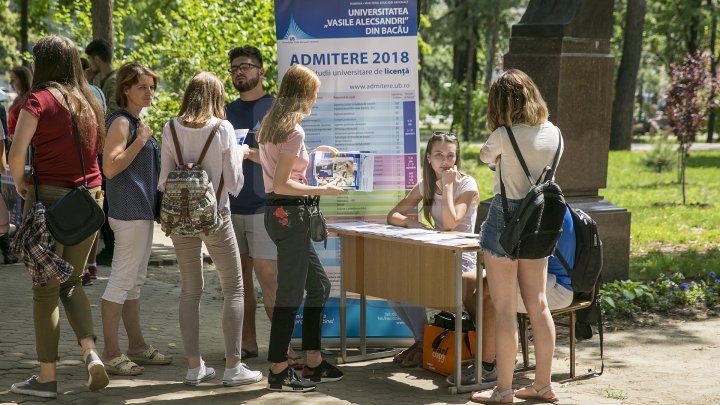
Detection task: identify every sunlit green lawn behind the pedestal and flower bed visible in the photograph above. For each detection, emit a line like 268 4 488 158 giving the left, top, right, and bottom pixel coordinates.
462 146 720 280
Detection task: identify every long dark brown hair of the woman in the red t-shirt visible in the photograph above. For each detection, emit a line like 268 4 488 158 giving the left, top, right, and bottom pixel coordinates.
31 35 105 151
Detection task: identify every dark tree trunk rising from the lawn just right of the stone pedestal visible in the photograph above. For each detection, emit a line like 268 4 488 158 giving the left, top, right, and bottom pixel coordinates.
610 0 646 150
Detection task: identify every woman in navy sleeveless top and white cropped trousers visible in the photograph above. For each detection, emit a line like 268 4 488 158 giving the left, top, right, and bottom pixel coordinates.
101 62 172 375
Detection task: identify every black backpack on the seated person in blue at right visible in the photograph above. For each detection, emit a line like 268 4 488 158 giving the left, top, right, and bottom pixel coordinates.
554 206 603 293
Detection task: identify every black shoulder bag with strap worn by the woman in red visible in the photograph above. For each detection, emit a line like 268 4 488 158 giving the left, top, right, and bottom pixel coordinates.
42 92 105 246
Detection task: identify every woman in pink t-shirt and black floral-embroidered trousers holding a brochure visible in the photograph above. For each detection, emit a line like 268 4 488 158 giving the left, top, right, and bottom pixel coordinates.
258 65 343 392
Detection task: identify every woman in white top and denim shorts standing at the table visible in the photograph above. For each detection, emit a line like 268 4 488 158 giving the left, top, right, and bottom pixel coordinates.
471 69 562 403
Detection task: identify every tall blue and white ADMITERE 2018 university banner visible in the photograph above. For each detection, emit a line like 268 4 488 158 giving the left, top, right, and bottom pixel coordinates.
275 0 419 337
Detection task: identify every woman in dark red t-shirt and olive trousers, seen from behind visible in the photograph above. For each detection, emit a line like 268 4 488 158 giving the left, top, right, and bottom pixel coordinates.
10 35 108 398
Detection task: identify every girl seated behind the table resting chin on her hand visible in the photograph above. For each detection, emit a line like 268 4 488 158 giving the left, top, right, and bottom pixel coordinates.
387 132 478 367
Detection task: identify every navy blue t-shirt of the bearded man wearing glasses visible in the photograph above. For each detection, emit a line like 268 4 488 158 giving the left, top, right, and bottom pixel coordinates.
225 94 275 215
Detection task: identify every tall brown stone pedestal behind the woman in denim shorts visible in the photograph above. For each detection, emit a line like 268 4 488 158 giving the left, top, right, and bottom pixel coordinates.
490 0 630 281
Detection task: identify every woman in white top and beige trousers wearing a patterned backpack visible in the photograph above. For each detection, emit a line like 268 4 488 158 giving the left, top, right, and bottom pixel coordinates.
158 72 262 386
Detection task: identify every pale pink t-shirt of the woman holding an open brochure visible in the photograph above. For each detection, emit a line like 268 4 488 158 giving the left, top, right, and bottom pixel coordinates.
260 124 310 193
